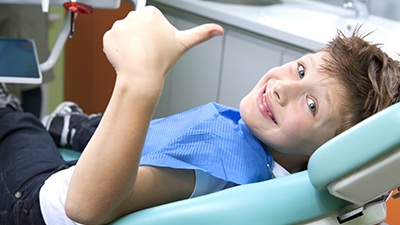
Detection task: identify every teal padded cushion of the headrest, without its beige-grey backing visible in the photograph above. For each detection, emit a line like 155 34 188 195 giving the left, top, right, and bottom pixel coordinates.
308 103 400 189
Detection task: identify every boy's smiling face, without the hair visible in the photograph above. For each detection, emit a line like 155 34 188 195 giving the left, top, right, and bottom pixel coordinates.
240 52 341 156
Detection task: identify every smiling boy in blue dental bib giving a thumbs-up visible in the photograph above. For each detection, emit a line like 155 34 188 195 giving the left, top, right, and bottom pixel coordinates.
0 7 399 224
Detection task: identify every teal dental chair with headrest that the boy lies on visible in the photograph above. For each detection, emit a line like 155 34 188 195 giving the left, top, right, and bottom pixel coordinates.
60 103 400 225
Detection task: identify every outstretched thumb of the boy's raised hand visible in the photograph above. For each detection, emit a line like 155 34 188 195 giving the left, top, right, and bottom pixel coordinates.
177 23 224 51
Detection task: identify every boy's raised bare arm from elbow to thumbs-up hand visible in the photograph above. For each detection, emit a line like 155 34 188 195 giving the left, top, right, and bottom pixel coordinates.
66 7 223 223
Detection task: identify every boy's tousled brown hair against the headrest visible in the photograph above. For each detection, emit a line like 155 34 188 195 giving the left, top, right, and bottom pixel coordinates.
321 27 400 134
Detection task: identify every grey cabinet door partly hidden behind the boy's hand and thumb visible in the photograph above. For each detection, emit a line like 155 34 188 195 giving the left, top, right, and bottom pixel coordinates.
155 15 223 117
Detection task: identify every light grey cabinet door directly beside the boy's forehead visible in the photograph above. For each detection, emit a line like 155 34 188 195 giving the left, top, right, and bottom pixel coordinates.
218 31 284 108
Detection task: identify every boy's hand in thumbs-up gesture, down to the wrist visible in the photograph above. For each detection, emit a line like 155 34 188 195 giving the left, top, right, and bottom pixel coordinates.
103 6 223 87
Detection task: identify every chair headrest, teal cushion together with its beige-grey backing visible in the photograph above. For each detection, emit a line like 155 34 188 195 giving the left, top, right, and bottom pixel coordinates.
308 103 400 205
